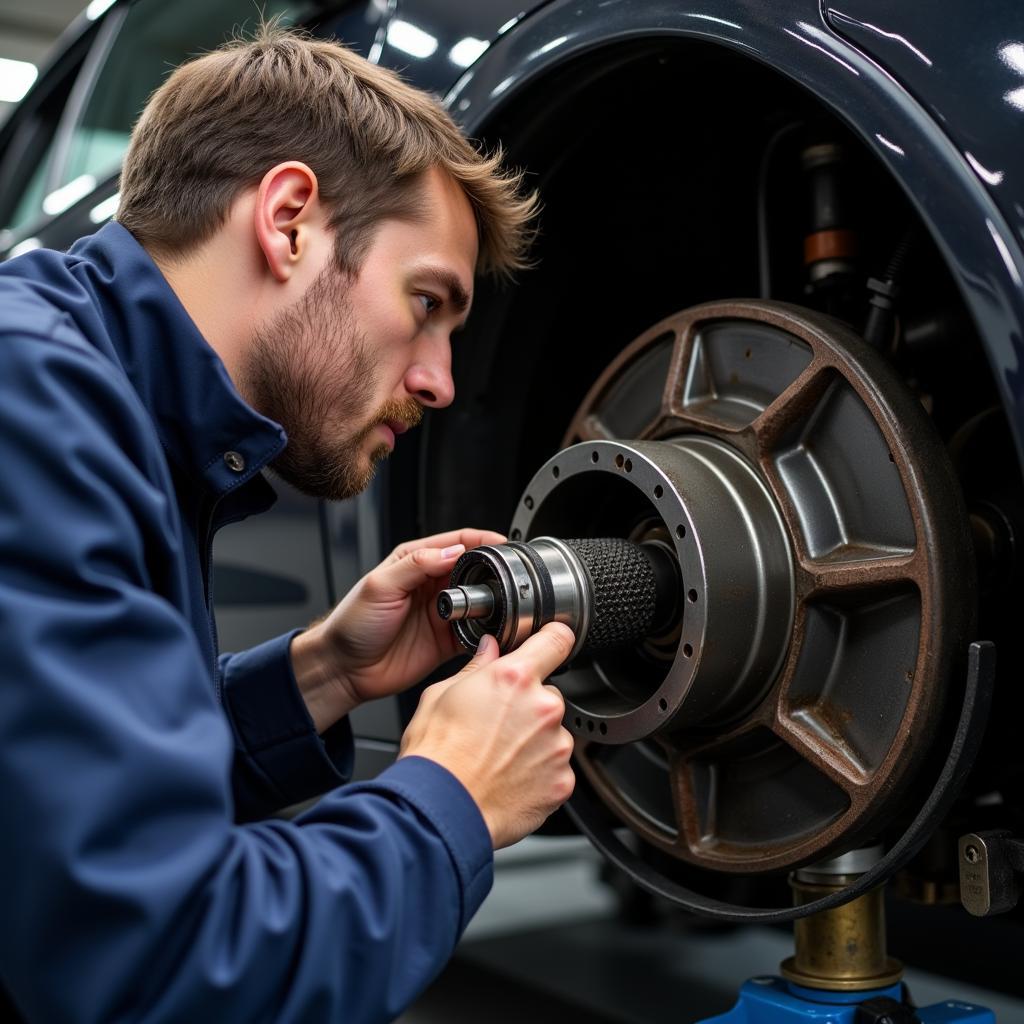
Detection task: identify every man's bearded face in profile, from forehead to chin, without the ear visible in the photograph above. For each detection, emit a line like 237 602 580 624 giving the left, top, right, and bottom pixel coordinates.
241 170 477 499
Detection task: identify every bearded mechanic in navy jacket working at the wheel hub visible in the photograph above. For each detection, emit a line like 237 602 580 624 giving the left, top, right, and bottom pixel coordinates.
0 25 573 1024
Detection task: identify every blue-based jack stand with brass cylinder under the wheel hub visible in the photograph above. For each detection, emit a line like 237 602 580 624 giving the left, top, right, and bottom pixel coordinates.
703 847 995 1024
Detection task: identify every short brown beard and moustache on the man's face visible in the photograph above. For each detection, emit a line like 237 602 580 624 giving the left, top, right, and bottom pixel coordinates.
240 268 423 500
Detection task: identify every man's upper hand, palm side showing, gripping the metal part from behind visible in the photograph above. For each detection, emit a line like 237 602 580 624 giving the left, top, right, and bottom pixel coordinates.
291 529 505 732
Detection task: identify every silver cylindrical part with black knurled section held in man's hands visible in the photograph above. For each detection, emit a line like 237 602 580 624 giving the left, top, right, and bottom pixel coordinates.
437 537 681 659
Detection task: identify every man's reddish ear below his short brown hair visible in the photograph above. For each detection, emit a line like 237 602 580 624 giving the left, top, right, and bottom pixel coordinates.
254 161 319 282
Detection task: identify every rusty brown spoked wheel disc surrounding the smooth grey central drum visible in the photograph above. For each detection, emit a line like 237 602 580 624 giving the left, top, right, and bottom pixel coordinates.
565 301 973 871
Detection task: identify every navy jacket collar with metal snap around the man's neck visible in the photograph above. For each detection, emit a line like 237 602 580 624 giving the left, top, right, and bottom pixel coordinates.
70 223 288 496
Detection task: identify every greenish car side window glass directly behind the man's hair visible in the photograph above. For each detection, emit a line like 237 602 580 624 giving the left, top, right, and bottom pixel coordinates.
52 0 315 195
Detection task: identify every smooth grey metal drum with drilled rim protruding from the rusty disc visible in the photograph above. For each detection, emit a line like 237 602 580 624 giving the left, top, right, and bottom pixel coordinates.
510 436 794 743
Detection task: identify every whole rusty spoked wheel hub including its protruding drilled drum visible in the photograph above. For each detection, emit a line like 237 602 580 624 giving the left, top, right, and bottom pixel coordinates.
511 301 973 871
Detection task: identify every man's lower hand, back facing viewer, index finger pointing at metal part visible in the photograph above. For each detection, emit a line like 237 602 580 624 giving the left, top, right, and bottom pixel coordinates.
398 623 575 850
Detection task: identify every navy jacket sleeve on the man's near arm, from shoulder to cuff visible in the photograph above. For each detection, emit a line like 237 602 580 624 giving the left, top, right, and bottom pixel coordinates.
0 336 492 1024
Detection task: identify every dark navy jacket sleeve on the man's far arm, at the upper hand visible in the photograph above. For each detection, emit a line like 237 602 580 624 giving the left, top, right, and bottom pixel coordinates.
218 630 353 821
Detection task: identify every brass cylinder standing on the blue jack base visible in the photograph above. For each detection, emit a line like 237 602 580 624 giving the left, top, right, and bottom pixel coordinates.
781 877 903 991
